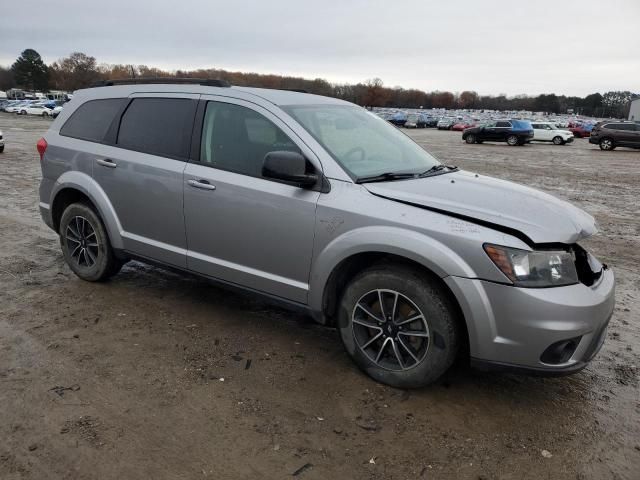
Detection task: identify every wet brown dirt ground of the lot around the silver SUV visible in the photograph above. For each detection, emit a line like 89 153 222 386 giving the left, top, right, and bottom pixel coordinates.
0 113 640 480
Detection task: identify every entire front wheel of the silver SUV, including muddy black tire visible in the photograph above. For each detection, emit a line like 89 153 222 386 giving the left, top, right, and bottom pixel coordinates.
338 264 459 388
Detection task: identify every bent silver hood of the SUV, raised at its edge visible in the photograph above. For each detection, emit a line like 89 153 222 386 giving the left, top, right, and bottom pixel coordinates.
363 171 597 244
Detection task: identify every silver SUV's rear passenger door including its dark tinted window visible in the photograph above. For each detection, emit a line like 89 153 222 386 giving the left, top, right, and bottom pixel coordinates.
93 94 199 268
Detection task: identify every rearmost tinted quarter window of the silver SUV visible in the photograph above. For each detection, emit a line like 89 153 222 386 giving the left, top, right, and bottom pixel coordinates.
60 98 126 142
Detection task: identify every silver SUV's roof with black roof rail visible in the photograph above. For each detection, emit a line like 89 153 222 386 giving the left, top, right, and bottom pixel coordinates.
75 83 353 106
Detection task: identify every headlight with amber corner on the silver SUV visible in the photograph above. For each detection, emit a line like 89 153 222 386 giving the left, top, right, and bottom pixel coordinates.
484 244 578 288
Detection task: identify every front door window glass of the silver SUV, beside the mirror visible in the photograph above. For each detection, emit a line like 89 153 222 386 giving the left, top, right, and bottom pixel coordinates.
200 102 302 177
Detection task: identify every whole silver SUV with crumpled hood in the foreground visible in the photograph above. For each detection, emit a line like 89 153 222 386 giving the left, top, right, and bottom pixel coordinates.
38 80 614 387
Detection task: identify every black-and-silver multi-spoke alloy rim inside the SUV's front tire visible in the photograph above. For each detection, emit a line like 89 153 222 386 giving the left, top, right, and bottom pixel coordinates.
351 289 430 371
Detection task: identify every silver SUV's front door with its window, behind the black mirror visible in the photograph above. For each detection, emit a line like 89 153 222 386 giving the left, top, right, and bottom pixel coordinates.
184 96 321 303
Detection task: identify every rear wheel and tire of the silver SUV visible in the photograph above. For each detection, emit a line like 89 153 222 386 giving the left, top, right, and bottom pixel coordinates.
58 203 123 282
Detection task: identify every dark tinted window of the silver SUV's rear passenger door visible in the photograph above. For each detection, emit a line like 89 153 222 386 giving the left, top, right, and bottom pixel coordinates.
116 98 196 158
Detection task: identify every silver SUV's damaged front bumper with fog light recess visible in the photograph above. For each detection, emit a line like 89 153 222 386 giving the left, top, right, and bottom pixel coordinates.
445 267 615 375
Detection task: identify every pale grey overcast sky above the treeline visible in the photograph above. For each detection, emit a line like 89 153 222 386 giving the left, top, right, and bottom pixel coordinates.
0 0 640 96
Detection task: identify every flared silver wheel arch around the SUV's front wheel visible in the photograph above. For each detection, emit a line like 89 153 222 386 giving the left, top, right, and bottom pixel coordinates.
309 226 474 312
